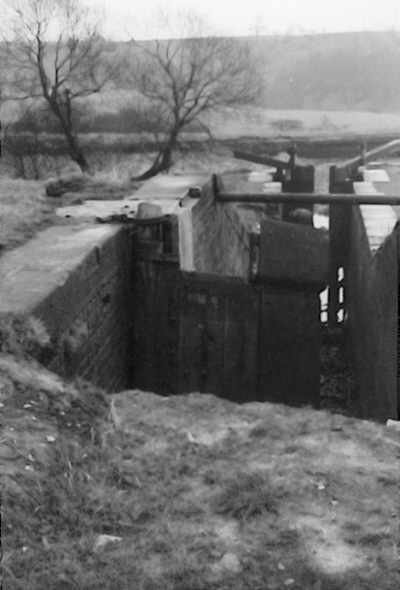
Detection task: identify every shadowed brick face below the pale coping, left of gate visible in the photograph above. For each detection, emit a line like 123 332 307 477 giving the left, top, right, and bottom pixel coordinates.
41 229 131 392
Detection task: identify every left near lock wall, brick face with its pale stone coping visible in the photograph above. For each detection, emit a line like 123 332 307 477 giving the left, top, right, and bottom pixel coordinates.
0 225 133 392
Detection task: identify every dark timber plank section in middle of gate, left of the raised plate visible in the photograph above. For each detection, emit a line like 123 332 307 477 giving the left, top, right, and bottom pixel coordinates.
179 274 259 401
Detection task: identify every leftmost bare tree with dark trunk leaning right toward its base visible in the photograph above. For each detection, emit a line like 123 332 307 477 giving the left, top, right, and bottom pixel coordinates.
2 0 117 172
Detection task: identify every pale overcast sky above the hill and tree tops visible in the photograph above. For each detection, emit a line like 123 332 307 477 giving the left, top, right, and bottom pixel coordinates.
85 0 400 39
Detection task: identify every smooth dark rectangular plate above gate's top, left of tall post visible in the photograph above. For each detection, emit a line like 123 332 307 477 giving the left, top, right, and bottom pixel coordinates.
259 219 329 289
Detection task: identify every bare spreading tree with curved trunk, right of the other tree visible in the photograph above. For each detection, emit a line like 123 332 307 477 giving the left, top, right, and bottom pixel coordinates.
125 23 263 180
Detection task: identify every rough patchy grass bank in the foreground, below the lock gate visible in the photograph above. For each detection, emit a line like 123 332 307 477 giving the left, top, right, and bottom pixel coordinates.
0 317 400 590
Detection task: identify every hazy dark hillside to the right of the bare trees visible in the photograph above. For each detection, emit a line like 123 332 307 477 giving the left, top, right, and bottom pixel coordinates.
248 31 400 112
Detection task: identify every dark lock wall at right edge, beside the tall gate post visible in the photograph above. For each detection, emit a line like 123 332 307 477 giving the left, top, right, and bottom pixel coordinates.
346 207 399 421
